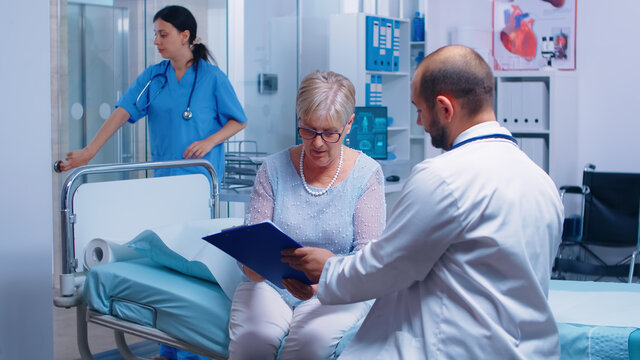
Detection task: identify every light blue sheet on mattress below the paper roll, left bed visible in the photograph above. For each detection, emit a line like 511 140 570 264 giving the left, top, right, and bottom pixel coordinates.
84 258 231 356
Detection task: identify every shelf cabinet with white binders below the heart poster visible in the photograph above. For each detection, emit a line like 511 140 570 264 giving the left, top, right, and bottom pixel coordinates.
494 70 579 186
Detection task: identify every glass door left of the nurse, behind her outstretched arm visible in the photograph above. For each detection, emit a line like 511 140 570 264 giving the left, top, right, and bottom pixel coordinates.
66 3 136 178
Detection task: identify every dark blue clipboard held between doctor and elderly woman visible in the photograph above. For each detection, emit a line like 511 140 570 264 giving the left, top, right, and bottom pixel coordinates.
203 222 312 289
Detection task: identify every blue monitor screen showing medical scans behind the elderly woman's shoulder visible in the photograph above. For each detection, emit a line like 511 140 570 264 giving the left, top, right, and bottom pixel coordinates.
345 106 387 159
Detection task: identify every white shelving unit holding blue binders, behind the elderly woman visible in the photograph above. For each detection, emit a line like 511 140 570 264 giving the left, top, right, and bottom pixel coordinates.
329 13 412 192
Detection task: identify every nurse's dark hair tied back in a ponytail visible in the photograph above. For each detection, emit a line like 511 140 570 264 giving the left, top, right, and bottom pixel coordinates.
153 5 216 65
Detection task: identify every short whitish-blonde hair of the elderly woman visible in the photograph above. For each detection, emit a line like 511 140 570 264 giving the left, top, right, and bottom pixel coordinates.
296 71 356 125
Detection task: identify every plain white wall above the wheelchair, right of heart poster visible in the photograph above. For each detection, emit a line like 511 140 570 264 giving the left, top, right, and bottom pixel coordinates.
576 0 640 172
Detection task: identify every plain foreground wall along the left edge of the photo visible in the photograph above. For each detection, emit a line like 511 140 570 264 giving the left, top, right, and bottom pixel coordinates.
0 0 53 360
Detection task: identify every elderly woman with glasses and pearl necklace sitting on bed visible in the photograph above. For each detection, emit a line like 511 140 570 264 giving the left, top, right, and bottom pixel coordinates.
229 71 386 359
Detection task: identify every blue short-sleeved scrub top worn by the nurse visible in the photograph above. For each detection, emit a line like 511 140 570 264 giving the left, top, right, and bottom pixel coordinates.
116 60 247 184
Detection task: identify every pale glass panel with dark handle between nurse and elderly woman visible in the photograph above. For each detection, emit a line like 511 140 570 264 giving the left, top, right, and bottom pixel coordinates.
240 0 298 153
